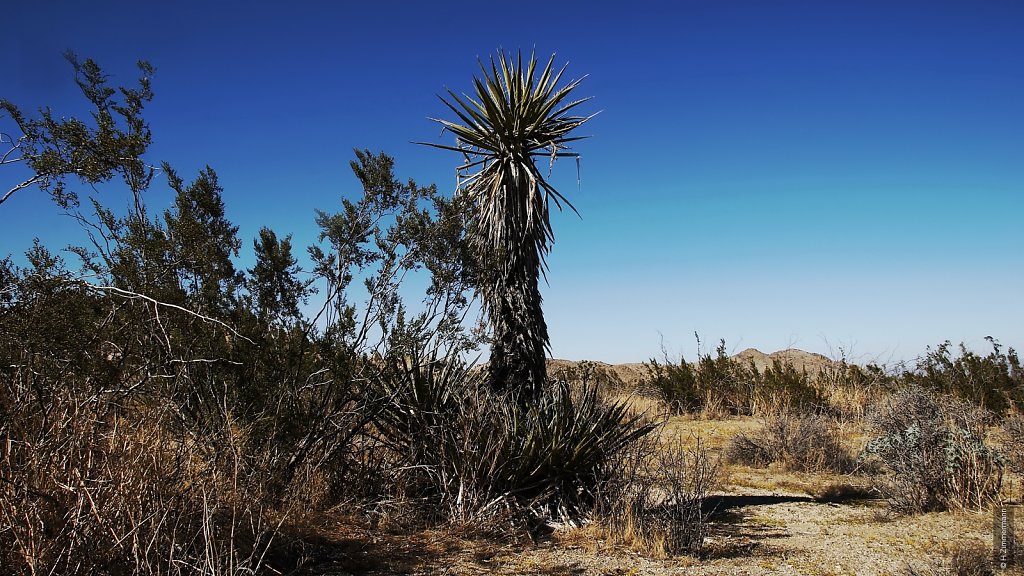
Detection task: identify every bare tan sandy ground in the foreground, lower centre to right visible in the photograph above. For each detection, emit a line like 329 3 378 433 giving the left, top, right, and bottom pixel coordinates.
292 417 1019 576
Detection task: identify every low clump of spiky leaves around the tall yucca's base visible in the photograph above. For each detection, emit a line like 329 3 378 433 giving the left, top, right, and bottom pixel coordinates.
374 348 652 523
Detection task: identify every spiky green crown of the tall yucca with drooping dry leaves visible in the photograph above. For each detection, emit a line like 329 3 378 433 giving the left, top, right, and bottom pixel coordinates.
425 52 592 274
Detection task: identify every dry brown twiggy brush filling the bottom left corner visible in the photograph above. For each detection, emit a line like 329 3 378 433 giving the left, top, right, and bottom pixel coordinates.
0 378 278 574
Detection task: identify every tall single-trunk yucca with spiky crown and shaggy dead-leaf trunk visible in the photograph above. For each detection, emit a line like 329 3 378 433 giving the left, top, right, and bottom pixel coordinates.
429 51 591 398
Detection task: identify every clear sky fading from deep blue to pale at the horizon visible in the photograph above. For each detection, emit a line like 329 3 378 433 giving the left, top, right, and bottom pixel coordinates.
0 0 1024 362
